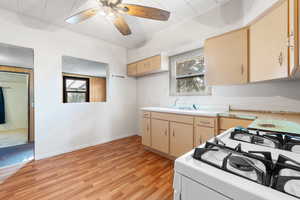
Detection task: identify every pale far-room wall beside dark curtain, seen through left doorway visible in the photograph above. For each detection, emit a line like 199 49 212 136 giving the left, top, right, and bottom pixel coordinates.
0 72 28 131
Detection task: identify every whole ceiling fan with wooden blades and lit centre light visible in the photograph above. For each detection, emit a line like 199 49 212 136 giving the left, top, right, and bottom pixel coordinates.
66 0 170 35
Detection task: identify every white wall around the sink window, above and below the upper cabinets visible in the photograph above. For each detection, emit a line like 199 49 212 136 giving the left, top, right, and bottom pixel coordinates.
128 0 300 134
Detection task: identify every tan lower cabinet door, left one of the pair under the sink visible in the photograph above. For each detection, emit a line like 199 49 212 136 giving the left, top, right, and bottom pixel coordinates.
151 119 169 153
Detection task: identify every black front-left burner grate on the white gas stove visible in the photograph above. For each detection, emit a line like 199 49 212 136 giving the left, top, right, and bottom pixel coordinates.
193 142 273 185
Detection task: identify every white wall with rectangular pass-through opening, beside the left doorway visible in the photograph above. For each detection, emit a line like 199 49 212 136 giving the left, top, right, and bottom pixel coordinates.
0 10 137 159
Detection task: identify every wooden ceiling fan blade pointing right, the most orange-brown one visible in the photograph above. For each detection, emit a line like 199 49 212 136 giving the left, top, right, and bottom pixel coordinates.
118 4 170 21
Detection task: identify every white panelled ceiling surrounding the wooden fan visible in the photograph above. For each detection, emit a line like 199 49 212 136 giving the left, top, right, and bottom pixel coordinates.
0 0 230 48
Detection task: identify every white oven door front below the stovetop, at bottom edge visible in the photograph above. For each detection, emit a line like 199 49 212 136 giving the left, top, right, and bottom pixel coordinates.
181 177 231 200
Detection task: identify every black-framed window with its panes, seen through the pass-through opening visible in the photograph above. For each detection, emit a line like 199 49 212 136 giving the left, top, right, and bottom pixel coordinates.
63 76 90 103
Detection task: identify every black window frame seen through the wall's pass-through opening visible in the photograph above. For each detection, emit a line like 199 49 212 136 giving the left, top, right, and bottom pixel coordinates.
63 75 90 103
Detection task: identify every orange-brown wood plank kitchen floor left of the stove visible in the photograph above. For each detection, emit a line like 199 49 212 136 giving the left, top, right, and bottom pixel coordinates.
0 136 173 200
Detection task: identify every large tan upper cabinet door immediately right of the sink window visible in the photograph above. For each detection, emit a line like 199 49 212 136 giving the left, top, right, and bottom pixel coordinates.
204 29 248 85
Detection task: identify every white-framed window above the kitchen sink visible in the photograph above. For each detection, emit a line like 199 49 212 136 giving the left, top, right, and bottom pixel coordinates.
170 49 211 95
